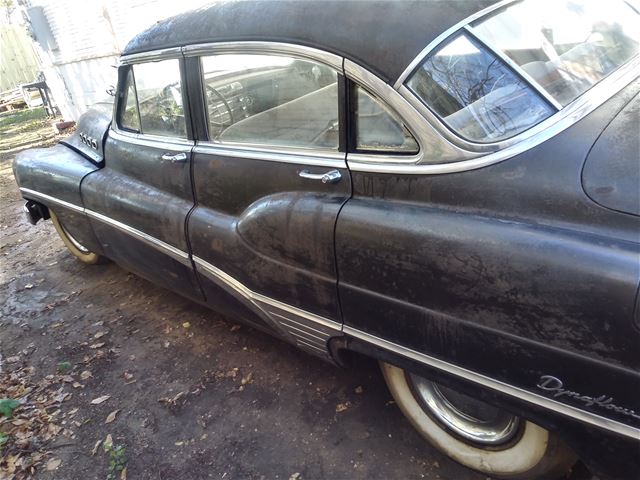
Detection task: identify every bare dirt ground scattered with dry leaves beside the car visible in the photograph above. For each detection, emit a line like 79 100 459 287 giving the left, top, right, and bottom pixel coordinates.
0 109 592 480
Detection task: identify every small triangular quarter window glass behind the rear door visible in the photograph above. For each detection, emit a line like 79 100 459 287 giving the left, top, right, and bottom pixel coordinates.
355 86 418 153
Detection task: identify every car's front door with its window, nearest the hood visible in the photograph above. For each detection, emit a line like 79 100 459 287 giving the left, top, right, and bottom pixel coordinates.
81 56 202 300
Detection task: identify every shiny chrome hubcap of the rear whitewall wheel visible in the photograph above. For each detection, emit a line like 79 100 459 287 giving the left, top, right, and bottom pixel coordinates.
408 374 520 446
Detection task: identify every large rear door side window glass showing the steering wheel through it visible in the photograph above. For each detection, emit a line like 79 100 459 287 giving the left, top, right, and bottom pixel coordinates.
202 54 338 149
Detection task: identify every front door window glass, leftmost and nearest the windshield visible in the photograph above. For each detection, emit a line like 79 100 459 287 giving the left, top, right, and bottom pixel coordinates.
133 59 187 138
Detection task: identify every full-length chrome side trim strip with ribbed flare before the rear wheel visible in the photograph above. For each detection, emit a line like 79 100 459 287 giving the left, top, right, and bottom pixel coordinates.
20 187 640 440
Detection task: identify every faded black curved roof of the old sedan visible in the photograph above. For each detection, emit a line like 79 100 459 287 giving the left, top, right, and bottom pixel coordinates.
123 0 496 83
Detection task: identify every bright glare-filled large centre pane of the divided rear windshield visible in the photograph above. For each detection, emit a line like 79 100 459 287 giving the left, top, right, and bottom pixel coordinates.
473 0 640 105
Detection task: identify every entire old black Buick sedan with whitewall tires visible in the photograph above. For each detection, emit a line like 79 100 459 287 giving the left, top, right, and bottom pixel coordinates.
14 0 640 480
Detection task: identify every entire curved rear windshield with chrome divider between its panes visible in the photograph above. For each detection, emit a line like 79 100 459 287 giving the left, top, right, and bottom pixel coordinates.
406 0 640 143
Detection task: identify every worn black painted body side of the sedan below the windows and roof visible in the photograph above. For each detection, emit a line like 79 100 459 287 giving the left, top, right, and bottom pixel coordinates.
14 1 640 478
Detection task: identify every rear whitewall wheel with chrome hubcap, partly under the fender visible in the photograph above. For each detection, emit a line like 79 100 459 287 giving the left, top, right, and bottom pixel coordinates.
380 362 577 480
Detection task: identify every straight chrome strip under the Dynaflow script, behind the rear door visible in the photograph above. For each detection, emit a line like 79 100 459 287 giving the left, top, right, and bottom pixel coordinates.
343 325 640 440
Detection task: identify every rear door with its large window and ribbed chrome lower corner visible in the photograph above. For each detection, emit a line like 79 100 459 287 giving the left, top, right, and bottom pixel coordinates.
188 52 351 354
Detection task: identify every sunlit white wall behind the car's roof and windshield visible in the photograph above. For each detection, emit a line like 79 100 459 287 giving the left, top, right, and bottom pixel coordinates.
22 0 211 120
